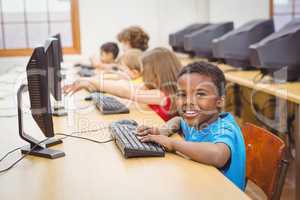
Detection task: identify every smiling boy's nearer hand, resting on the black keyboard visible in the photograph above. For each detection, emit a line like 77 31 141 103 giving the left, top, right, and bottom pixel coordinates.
139 134 175 152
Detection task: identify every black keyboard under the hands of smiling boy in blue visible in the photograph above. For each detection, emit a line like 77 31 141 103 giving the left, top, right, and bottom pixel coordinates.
110 123 165 158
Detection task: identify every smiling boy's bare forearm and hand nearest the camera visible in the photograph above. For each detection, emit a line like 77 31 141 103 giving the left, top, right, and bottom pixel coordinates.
141 134 231 168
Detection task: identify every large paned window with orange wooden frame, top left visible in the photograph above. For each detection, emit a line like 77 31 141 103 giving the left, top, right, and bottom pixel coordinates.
0 0 80 56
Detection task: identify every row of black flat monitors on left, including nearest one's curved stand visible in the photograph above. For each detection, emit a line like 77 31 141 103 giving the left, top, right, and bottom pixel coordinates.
18 34 65 159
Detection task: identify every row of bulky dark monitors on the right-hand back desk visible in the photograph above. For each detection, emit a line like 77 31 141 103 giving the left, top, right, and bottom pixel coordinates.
169 18 300 81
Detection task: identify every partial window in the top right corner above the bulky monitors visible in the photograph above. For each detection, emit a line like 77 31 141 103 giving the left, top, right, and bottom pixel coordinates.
270 0 300 30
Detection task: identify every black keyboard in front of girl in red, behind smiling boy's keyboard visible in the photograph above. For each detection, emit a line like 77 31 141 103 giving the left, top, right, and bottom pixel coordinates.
91 92 129 114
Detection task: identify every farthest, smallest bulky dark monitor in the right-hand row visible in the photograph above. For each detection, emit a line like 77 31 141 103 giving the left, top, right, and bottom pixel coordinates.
169 23 208 53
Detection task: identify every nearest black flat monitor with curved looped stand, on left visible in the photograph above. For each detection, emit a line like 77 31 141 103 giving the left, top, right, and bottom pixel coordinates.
17 47 65 159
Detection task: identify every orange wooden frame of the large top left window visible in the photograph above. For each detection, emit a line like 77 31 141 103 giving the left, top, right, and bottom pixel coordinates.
0 0 81 57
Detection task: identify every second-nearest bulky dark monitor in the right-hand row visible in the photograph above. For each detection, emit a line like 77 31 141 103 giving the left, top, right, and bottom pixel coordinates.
213 19 274 69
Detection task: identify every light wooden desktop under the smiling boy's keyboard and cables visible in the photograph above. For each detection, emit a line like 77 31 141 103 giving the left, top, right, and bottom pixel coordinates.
0 74 249 200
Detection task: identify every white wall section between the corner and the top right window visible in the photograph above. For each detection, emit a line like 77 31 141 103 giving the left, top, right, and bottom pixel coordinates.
209 0 269 27
